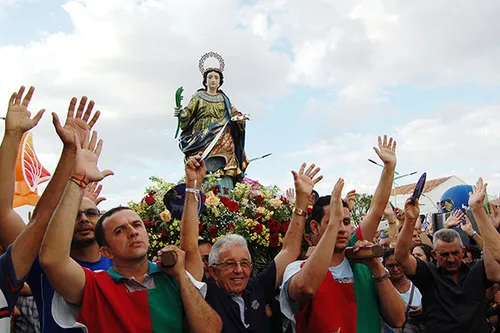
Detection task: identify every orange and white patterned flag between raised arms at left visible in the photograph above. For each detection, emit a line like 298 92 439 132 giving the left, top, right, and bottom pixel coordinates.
13 132 50 208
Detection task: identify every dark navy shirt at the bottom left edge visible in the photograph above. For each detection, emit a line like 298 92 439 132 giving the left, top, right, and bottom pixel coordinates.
0 245 24 333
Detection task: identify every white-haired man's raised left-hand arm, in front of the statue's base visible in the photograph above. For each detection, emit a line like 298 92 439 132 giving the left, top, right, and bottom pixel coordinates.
180 154 207 281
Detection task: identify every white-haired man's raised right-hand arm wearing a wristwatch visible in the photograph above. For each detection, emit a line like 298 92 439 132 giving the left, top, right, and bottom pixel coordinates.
274 163 323 287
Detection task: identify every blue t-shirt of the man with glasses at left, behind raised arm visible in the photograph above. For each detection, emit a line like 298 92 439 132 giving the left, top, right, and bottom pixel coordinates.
26 256 113 333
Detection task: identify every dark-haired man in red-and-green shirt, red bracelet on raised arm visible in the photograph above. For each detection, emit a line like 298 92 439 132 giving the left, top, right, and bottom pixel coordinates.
40 132 222 333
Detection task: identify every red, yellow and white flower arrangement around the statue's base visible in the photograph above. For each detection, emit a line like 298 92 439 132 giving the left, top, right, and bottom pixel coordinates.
129 175 293 271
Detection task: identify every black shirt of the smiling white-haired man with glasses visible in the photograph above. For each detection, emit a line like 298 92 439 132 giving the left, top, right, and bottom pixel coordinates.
205 260 276 333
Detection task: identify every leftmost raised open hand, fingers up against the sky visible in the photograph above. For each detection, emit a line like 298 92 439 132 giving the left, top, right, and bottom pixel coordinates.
5 86 45 134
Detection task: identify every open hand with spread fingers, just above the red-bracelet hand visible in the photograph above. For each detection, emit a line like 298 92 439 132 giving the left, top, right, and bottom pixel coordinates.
52 96 101 147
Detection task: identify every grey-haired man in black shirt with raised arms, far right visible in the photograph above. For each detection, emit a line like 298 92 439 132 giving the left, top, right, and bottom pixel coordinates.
395 179 500 333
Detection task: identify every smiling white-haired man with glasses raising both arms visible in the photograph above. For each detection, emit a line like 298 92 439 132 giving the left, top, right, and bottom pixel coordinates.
181 155 322 333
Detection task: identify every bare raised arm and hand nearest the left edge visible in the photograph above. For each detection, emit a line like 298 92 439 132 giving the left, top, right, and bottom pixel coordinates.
0 87 45 248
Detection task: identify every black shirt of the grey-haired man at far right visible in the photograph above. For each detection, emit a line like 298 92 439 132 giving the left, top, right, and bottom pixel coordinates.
409 258 492 333
